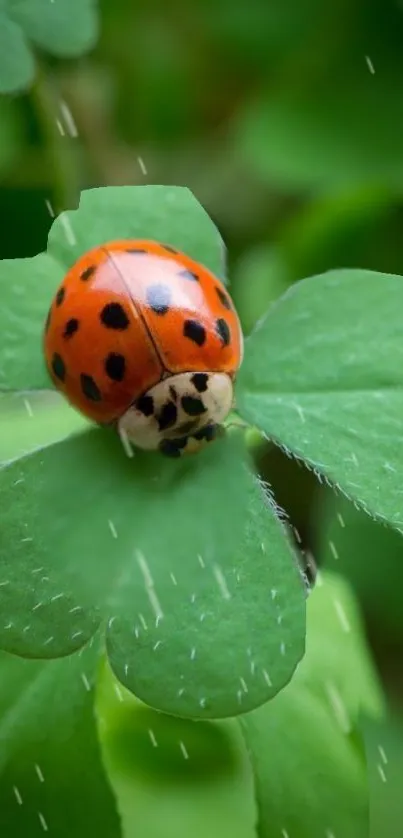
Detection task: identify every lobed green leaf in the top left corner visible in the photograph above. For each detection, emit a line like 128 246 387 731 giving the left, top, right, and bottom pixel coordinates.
0 0 98 93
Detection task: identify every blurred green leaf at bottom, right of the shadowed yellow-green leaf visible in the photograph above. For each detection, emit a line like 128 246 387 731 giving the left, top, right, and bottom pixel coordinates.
241 688 368 838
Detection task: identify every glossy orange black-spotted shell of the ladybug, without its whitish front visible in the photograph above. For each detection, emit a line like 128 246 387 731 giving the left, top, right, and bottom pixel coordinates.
44 240 242 423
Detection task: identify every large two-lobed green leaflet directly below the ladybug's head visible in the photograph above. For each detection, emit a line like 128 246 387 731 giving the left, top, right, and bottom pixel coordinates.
0 430 305 718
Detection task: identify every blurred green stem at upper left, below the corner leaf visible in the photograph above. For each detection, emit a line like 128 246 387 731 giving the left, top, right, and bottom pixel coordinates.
31 66 80 214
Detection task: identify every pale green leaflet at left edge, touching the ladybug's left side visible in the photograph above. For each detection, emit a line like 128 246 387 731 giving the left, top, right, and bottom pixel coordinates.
0 253 64 390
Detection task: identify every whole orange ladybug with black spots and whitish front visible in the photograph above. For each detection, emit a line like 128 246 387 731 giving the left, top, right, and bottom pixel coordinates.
44 240 243 457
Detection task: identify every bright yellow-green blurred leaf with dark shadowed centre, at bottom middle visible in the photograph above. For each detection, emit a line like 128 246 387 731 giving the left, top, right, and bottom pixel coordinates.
96 668 256 838
